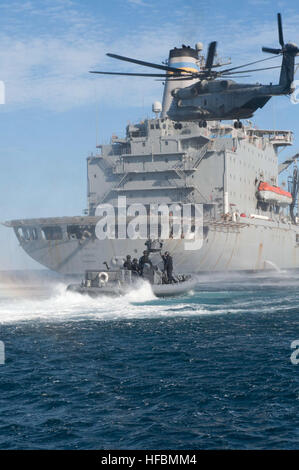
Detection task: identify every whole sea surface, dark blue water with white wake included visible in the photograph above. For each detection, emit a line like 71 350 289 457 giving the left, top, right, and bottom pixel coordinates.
0 271 299 450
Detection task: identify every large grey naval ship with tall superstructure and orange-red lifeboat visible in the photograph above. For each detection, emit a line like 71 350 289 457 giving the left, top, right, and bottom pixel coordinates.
5 46 299 276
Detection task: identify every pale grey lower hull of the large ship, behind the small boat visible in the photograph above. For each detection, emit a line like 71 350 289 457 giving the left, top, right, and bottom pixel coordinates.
10 219 299 276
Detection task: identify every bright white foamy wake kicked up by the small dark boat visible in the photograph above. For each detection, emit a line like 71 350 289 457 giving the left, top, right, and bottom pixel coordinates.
0 283 210 324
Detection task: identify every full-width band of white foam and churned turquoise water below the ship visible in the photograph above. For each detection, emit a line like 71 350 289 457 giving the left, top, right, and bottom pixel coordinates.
0 272 299 324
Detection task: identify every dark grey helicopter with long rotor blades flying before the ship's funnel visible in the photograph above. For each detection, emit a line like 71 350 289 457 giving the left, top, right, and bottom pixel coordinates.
90 13 299 128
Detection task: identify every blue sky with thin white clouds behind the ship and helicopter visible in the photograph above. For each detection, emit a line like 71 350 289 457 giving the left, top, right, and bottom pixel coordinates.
0 0 299 270
